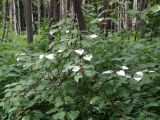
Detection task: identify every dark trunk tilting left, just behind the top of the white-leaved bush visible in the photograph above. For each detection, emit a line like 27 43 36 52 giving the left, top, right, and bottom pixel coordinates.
73 0 86 31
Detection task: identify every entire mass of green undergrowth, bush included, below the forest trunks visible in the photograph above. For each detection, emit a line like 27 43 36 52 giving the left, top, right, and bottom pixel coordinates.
0 1 160 120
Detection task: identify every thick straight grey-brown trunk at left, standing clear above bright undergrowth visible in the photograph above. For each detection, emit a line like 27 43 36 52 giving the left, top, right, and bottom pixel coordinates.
24 0 33 43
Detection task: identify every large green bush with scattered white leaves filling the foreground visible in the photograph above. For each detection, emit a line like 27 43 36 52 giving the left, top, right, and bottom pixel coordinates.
0 26 160 120
